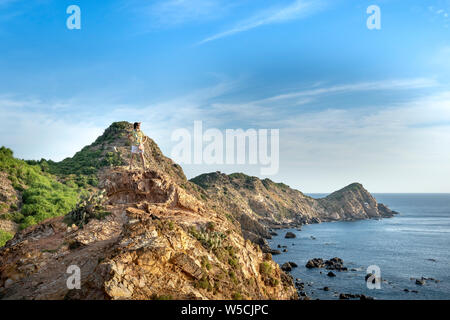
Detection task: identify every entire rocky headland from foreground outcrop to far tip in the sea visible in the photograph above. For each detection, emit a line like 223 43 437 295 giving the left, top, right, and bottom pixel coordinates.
0 122 395 299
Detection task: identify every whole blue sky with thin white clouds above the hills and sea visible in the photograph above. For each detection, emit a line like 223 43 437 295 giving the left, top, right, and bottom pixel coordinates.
0 0 450 192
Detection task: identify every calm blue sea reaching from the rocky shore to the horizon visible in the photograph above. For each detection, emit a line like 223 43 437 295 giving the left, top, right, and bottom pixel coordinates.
269 194 450 299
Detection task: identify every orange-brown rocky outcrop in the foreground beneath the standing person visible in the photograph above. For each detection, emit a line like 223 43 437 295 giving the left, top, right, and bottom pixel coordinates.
0 168 297 299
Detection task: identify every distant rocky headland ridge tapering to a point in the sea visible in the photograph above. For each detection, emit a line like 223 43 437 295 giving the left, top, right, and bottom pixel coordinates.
191 172 396 241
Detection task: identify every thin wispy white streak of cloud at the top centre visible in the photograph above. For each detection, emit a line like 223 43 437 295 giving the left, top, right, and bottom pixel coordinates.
198 0 323 44
